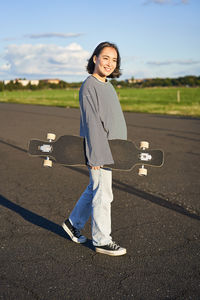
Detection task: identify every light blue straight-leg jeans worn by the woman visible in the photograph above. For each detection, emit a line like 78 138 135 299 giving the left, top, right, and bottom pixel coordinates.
69 168 113 246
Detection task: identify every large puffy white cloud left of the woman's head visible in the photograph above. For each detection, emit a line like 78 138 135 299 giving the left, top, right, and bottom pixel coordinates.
0 43 89 77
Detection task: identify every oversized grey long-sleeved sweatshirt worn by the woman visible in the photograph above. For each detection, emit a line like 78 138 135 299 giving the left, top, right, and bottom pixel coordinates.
79 75 127 166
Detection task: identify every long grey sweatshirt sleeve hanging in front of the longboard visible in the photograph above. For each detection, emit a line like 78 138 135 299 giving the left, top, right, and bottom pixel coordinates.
80 94 114 166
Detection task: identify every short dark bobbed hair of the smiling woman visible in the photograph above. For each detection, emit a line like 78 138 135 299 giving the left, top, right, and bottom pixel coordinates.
86 42 121 78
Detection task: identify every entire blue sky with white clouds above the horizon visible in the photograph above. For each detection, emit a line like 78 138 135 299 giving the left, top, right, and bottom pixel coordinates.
0 0 200 82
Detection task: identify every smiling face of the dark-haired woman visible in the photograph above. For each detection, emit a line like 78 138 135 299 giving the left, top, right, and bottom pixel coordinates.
93 47 117 81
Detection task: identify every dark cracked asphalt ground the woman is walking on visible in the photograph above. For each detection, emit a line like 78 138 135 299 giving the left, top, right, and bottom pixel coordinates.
0 103 200 300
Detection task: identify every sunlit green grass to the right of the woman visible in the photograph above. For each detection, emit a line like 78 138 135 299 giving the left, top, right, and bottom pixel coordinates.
117 88 200 117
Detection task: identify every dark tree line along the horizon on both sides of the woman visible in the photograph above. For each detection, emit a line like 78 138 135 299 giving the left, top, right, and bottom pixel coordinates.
0 76 200 92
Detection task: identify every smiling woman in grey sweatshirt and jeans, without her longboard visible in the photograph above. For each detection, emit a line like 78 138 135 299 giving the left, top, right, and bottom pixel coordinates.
62 42 127 256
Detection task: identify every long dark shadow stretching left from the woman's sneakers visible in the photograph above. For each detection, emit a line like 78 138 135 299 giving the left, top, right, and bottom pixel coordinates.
0 195 94 250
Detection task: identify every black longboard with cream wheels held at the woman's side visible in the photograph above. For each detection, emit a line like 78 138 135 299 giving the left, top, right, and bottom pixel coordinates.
28 133 164 176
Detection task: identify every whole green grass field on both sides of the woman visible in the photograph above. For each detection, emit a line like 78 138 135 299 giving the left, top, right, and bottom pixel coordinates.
0 87 200 117
